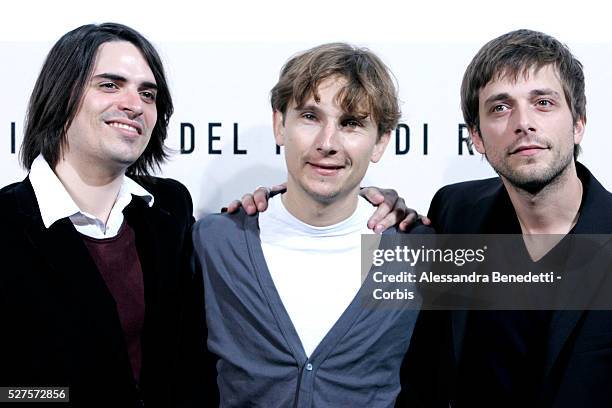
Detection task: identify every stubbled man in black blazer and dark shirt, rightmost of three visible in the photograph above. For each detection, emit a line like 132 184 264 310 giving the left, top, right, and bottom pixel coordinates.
406 30 612 407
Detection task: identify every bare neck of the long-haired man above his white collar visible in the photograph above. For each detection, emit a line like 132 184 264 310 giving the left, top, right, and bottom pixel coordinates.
54 159 124 223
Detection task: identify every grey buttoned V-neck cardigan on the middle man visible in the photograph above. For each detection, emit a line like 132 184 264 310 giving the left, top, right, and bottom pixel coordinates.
193 211 418 408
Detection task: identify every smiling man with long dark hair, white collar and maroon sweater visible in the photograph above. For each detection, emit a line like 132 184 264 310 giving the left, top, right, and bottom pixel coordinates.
0 23 208 407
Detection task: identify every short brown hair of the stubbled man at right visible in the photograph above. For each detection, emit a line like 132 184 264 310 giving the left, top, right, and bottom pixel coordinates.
461 29 586 157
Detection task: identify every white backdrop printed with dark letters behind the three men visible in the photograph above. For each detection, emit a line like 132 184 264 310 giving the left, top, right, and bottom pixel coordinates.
0 1 612 215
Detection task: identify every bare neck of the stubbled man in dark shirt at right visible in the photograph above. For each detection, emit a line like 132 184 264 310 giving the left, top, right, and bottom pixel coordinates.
502 162 582 234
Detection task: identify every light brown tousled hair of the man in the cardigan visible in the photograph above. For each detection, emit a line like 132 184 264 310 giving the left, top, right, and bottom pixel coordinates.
270 43 401 136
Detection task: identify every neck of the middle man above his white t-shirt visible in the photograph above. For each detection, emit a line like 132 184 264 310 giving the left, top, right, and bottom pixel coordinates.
282 183 359 227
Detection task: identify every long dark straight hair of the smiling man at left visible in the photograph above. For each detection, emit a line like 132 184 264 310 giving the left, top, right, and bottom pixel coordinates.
20 23 174 175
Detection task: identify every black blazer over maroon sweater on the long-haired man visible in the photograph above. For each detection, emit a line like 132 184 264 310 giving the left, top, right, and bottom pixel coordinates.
0 177 193 407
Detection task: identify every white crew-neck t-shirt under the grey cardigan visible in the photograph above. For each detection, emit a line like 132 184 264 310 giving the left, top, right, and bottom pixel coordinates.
259 195 374 356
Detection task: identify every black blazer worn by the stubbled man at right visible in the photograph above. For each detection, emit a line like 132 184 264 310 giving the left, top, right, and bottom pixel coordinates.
403 163 612 408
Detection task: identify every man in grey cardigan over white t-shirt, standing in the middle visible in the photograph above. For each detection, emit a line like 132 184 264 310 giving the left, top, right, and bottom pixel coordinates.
193 43 428 407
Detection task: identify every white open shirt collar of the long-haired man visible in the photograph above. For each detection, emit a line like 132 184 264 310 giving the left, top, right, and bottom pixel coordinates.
29 154 154 238
